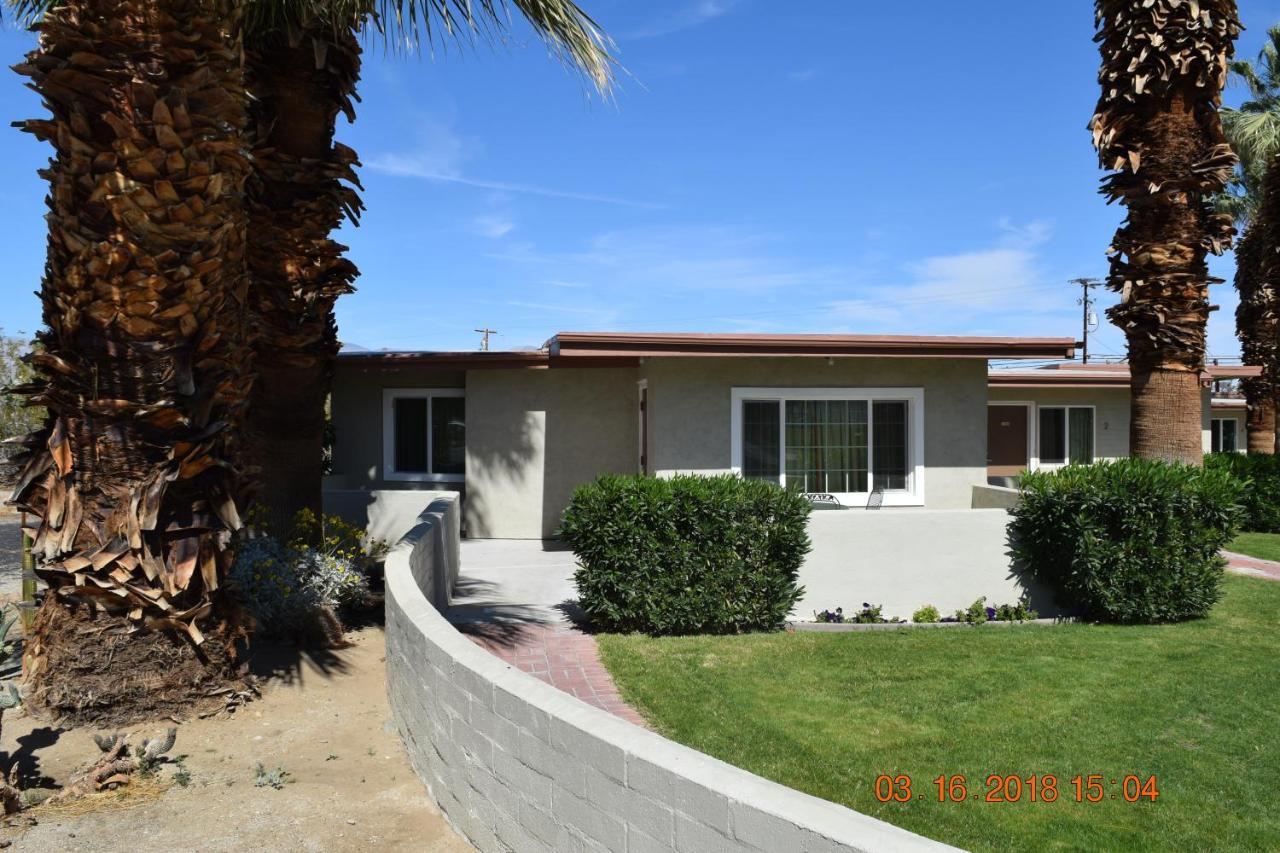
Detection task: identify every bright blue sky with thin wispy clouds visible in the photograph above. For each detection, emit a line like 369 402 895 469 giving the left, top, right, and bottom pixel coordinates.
0 0 1280 356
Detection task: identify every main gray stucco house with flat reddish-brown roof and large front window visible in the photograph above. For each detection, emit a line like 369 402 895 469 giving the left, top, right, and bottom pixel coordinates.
326 333 1075 538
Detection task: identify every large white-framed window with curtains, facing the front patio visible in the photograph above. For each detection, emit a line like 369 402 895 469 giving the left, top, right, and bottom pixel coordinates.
731 388 924 506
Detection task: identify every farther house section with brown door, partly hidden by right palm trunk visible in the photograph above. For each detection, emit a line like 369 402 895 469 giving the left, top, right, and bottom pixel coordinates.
987 364 1261 482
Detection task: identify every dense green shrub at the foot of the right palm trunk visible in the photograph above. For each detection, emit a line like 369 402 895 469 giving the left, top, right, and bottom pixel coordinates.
1009 459 1242 622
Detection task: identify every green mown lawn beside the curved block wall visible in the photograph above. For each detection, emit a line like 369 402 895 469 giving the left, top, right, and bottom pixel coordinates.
600 576 1280 850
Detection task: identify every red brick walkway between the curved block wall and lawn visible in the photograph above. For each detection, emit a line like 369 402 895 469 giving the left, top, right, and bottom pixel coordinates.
471 625 648 727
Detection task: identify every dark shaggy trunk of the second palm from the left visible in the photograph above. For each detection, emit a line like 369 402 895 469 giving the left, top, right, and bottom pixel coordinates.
248 24 361 530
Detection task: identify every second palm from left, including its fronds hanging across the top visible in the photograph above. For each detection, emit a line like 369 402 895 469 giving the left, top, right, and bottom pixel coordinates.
246 0 613 528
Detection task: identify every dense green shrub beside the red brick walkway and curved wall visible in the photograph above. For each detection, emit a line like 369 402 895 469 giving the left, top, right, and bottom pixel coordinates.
559 475 812 634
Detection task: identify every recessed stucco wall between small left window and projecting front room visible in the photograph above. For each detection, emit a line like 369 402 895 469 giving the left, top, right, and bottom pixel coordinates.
465 368 639 539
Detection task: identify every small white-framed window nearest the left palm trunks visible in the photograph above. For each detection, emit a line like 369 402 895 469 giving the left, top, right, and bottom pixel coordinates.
383 388 467 483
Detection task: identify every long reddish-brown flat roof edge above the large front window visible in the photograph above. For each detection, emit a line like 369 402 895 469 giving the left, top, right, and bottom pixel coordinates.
547 332 1076 362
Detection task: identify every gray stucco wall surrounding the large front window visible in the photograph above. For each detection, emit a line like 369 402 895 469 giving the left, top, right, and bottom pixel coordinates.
640 359 987 510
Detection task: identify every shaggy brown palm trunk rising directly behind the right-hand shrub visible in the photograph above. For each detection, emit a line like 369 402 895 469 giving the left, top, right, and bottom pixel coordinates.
1089 0 1240 465
